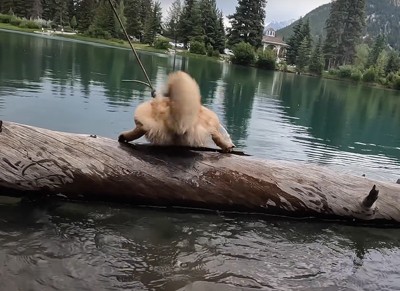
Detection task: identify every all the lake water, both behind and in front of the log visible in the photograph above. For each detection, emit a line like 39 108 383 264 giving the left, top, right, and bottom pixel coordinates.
0 31 400 291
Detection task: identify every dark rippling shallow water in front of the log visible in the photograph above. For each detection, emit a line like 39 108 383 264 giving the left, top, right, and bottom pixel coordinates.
0 203 400 290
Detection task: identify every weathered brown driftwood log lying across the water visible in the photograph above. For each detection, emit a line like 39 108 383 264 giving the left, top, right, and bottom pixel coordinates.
0 122 400 225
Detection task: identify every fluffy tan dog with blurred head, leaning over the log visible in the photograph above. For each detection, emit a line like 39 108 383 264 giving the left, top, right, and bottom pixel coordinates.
118 71 234 152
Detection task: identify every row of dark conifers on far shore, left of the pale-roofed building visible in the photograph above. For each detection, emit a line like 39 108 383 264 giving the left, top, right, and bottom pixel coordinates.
0 0 266 54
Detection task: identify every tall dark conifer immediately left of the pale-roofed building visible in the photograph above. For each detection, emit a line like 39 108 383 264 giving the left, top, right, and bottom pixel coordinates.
228 0 266 48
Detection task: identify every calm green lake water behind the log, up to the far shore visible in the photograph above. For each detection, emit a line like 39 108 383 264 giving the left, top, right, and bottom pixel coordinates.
0 32 400 181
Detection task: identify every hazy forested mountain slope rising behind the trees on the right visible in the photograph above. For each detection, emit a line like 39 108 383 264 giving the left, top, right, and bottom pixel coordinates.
276 0 400 50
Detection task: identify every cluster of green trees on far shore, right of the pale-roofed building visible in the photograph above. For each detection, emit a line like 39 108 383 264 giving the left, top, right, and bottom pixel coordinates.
286 0 400 89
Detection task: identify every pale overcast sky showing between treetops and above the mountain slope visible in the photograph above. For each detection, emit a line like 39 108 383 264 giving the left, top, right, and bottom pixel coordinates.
159 0 331 22
